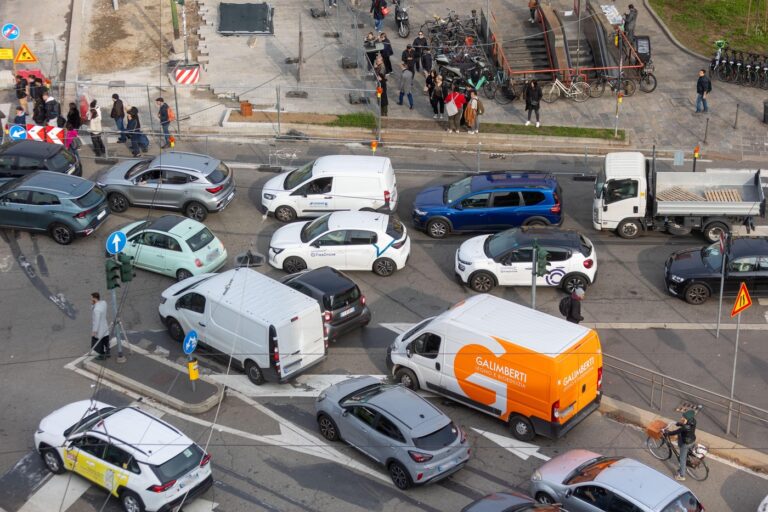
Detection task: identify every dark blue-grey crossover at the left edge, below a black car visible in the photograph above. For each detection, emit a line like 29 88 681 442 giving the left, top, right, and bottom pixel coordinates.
0 171 109 245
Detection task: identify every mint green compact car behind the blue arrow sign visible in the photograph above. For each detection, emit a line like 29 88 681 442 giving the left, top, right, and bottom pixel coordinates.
120 215 227 281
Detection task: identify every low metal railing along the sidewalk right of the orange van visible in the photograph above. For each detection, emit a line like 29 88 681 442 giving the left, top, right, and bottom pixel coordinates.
603 354 768 437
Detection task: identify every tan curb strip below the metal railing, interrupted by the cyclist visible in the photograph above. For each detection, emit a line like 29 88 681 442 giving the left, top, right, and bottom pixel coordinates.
599 396 768 474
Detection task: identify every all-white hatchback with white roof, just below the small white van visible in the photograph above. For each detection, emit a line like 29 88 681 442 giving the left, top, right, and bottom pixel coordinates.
269 212 411 276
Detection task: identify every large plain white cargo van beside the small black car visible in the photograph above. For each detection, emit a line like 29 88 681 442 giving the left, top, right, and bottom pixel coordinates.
159 268 328 384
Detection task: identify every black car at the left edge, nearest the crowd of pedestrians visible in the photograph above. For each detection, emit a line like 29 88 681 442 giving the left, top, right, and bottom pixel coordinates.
0 140 83 178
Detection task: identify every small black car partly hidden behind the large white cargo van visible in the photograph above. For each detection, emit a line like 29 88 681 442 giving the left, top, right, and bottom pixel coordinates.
283 267 371 341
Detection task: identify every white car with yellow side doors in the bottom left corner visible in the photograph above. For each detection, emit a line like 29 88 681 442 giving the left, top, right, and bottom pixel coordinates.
35 400 213 512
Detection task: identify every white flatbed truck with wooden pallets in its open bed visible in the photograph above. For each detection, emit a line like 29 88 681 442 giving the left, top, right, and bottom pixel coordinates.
592 152 766 242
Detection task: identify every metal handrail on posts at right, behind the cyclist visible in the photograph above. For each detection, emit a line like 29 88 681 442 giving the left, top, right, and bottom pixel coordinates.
603 353 768 437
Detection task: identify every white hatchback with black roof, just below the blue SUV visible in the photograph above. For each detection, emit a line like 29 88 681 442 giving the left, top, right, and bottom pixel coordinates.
455 227 597 293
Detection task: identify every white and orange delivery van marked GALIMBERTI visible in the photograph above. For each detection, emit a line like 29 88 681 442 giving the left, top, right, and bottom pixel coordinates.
387 295 603 441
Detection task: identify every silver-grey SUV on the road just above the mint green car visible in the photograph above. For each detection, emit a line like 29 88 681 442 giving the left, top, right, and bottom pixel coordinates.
94 151 235 218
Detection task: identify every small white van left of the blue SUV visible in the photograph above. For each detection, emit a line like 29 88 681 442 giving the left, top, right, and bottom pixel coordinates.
261 155 397 222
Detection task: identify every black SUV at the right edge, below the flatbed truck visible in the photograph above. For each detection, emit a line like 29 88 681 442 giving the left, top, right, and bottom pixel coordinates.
664 237 768 304
